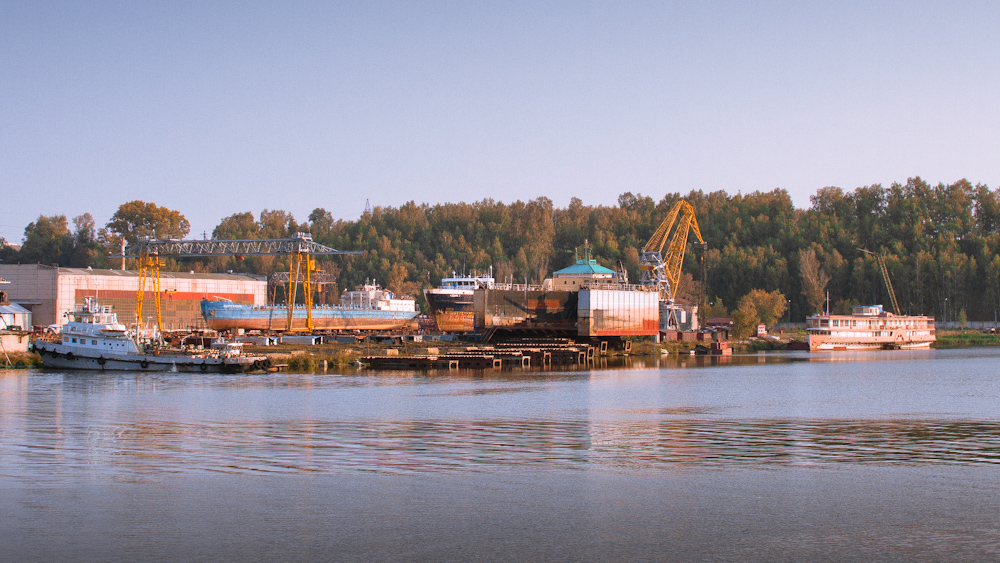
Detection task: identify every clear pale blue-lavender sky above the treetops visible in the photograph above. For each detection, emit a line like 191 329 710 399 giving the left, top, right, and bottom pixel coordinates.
0 0 1000 242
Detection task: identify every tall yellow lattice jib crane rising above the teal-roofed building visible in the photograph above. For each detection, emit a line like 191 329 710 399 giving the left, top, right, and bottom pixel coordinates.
639 199 705 301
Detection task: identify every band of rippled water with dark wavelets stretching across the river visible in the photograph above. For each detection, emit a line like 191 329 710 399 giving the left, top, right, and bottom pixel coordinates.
3 416 1000 475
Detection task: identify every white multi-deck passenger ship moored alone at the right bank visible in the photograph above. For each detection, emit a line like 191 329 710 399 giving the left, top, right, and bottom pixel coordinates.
807 305 936 352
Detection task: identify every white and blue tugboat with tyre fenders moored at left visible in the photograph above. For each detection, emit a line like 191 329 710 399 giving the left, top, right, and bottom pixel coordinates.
34 297 270 373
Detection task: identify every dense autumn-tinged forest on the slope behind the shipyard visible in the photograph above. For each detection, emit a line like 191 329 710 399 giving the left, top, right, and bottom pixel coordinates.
0 177 1000 322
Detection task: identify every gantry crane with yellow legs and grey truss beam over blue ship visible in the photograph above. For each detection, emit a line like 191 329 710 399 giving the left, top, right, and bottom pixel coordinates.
123 233 362 334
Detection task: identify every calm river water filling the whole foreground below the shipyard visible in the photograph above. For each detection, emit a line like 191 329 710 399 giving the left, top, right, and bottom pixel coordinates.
0 348 1000 561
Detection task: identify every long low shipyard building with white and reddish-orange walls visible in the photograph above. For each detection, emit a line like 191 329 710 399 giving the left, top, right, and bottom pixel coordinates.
0 264 267 330
